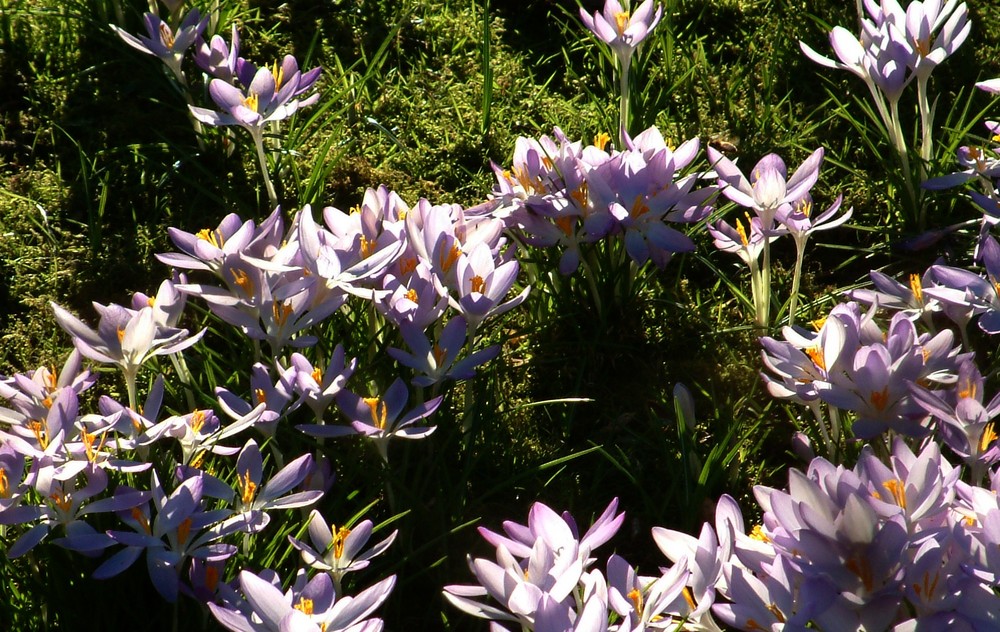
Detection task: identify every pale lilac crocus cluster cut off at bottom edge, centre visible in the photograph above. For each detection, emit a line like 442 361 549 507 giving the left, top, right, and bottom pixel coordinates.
444 500 689 632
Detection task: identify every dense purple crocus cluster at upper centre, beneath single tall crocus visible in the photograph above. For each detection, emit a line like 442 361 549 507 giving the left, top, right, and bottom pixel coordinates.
494 127 715 274
